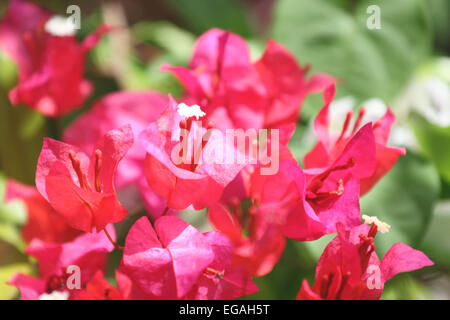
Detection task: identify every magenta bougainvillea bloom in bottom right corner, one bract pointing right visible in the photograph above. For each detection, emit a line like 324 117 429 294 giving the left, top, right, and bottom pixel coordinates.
297 219 433 300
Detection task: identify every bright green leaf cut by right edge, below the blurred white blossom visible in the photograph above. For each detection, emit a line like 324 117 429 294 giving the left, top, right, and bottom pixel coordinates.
410 113 450 181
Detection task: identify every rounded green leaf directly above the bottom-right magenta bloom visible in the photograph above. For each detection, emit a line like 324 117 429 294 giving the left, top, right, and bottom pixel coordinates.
361 153 440 256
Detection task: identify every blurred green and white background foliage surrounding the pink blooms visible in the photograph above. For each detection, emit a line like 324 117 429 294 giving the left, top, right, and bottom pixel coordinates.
0 0 450 299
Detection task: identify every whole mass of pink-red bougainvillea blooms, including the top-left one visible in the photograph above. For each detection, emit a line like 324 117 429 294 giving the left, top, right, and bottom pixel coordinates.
0 0 433 299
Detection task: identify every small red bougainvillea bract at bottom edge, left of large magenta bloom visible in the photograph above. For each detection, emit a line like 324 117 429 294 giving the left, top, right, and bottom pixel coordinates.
71 270 131 300
